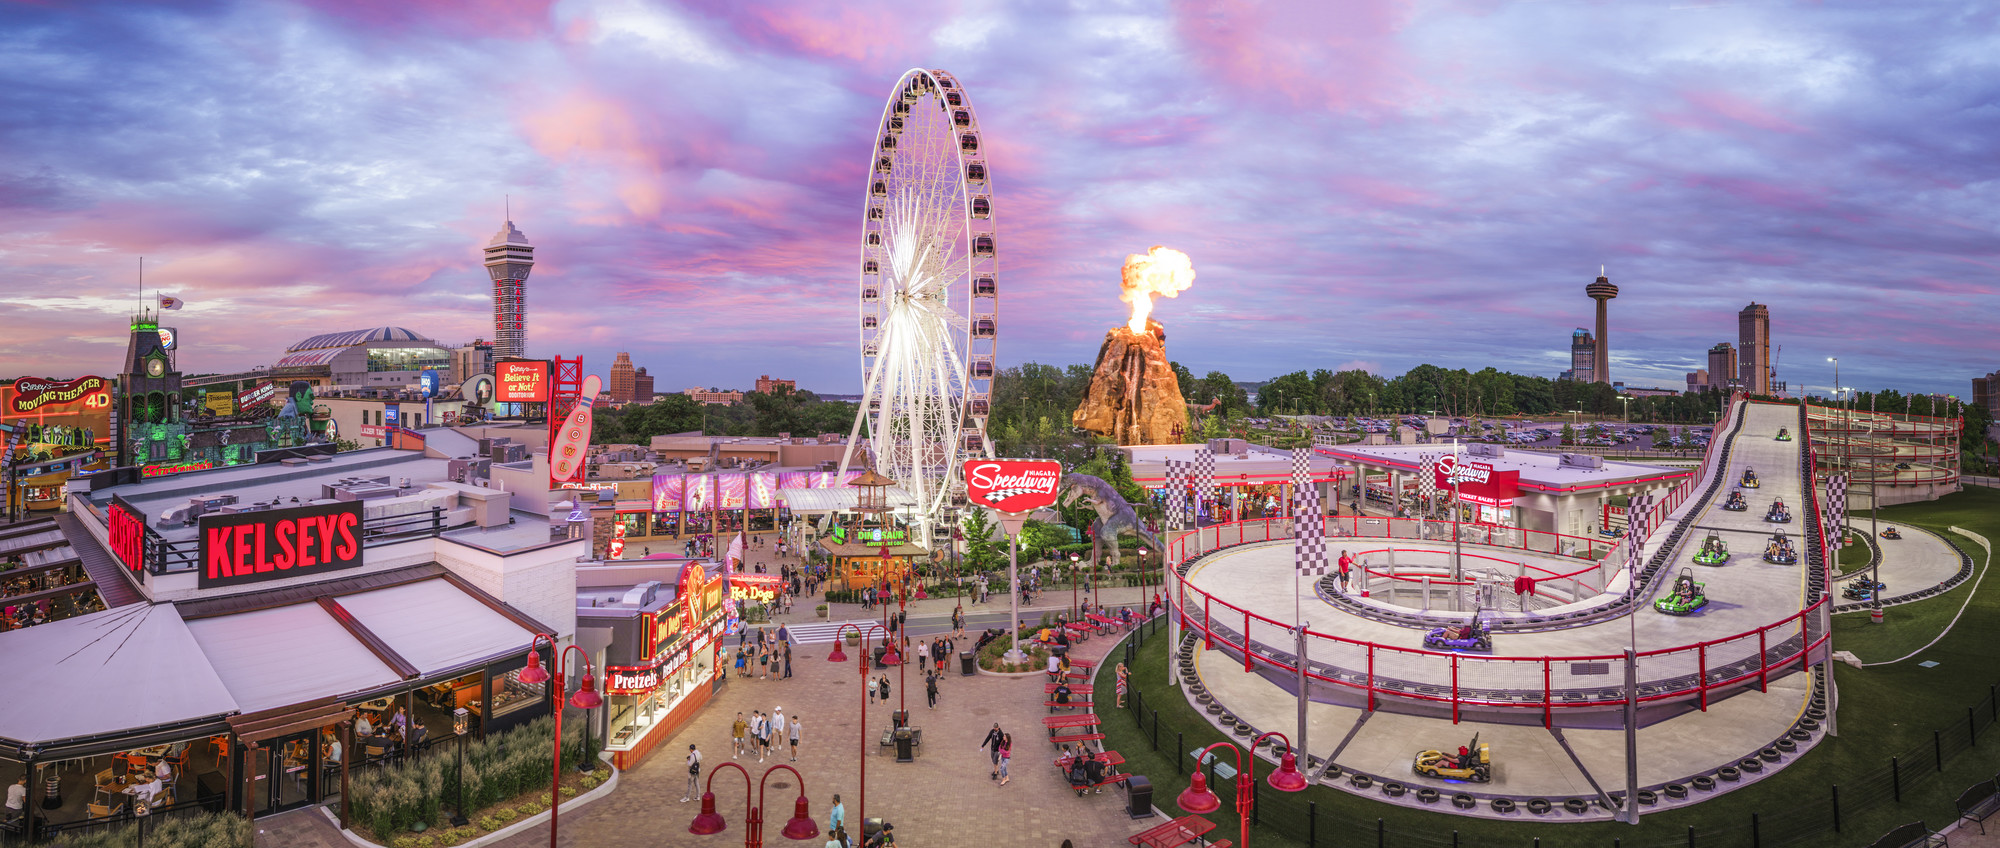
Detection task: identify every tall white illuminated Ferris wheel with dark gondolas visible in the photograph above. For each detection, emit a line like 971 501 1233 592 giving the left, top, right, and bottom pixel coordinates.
842 70 1000 546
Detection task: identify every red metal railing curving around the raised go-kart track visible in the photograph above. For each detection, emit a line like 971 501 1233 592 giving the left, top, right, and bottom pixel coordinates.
1168 396 1828 726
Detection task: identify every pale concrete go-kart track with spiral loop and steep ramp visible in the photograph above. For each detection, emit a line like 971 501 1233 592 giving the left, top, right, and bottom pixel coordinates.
1170 402 1960 820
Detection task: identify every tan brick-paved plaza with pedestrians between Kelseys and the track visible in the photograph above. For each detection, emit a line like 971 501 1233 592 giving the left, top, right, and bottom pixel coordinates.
258 548 1162 848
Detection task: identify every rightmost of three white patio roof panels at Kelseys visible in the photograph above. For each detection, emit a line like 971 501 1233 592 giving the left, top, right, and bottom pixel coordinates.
336 578 534 674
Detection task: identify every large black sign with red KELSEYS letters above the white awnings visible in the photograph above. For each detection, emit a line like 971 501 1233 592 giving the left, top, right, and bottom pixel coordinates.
196 502 362 588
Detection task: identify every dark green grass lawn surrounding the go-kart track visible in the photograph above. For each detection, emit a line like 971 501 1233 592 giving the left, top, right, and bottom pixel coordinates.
1098 486 2000 848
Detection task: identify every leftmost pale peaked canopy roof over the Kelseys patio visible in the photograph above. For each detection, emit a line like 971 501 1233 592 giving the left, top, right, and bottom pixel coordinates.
0 604 238 744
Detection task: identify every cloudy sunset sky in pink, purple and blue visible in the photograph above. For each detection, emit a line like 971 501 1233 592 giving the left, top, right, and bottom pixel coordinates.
0 0 2000 396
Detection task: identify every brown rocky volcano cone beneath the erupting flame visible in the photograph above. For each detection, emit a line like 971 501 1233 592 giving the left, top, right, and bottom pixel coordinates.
1070 320 1188 444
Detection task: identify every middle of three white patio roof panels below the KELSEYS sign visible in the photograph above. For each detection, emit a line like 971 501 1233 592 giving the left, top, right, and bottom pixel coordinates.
188 604 400 712
